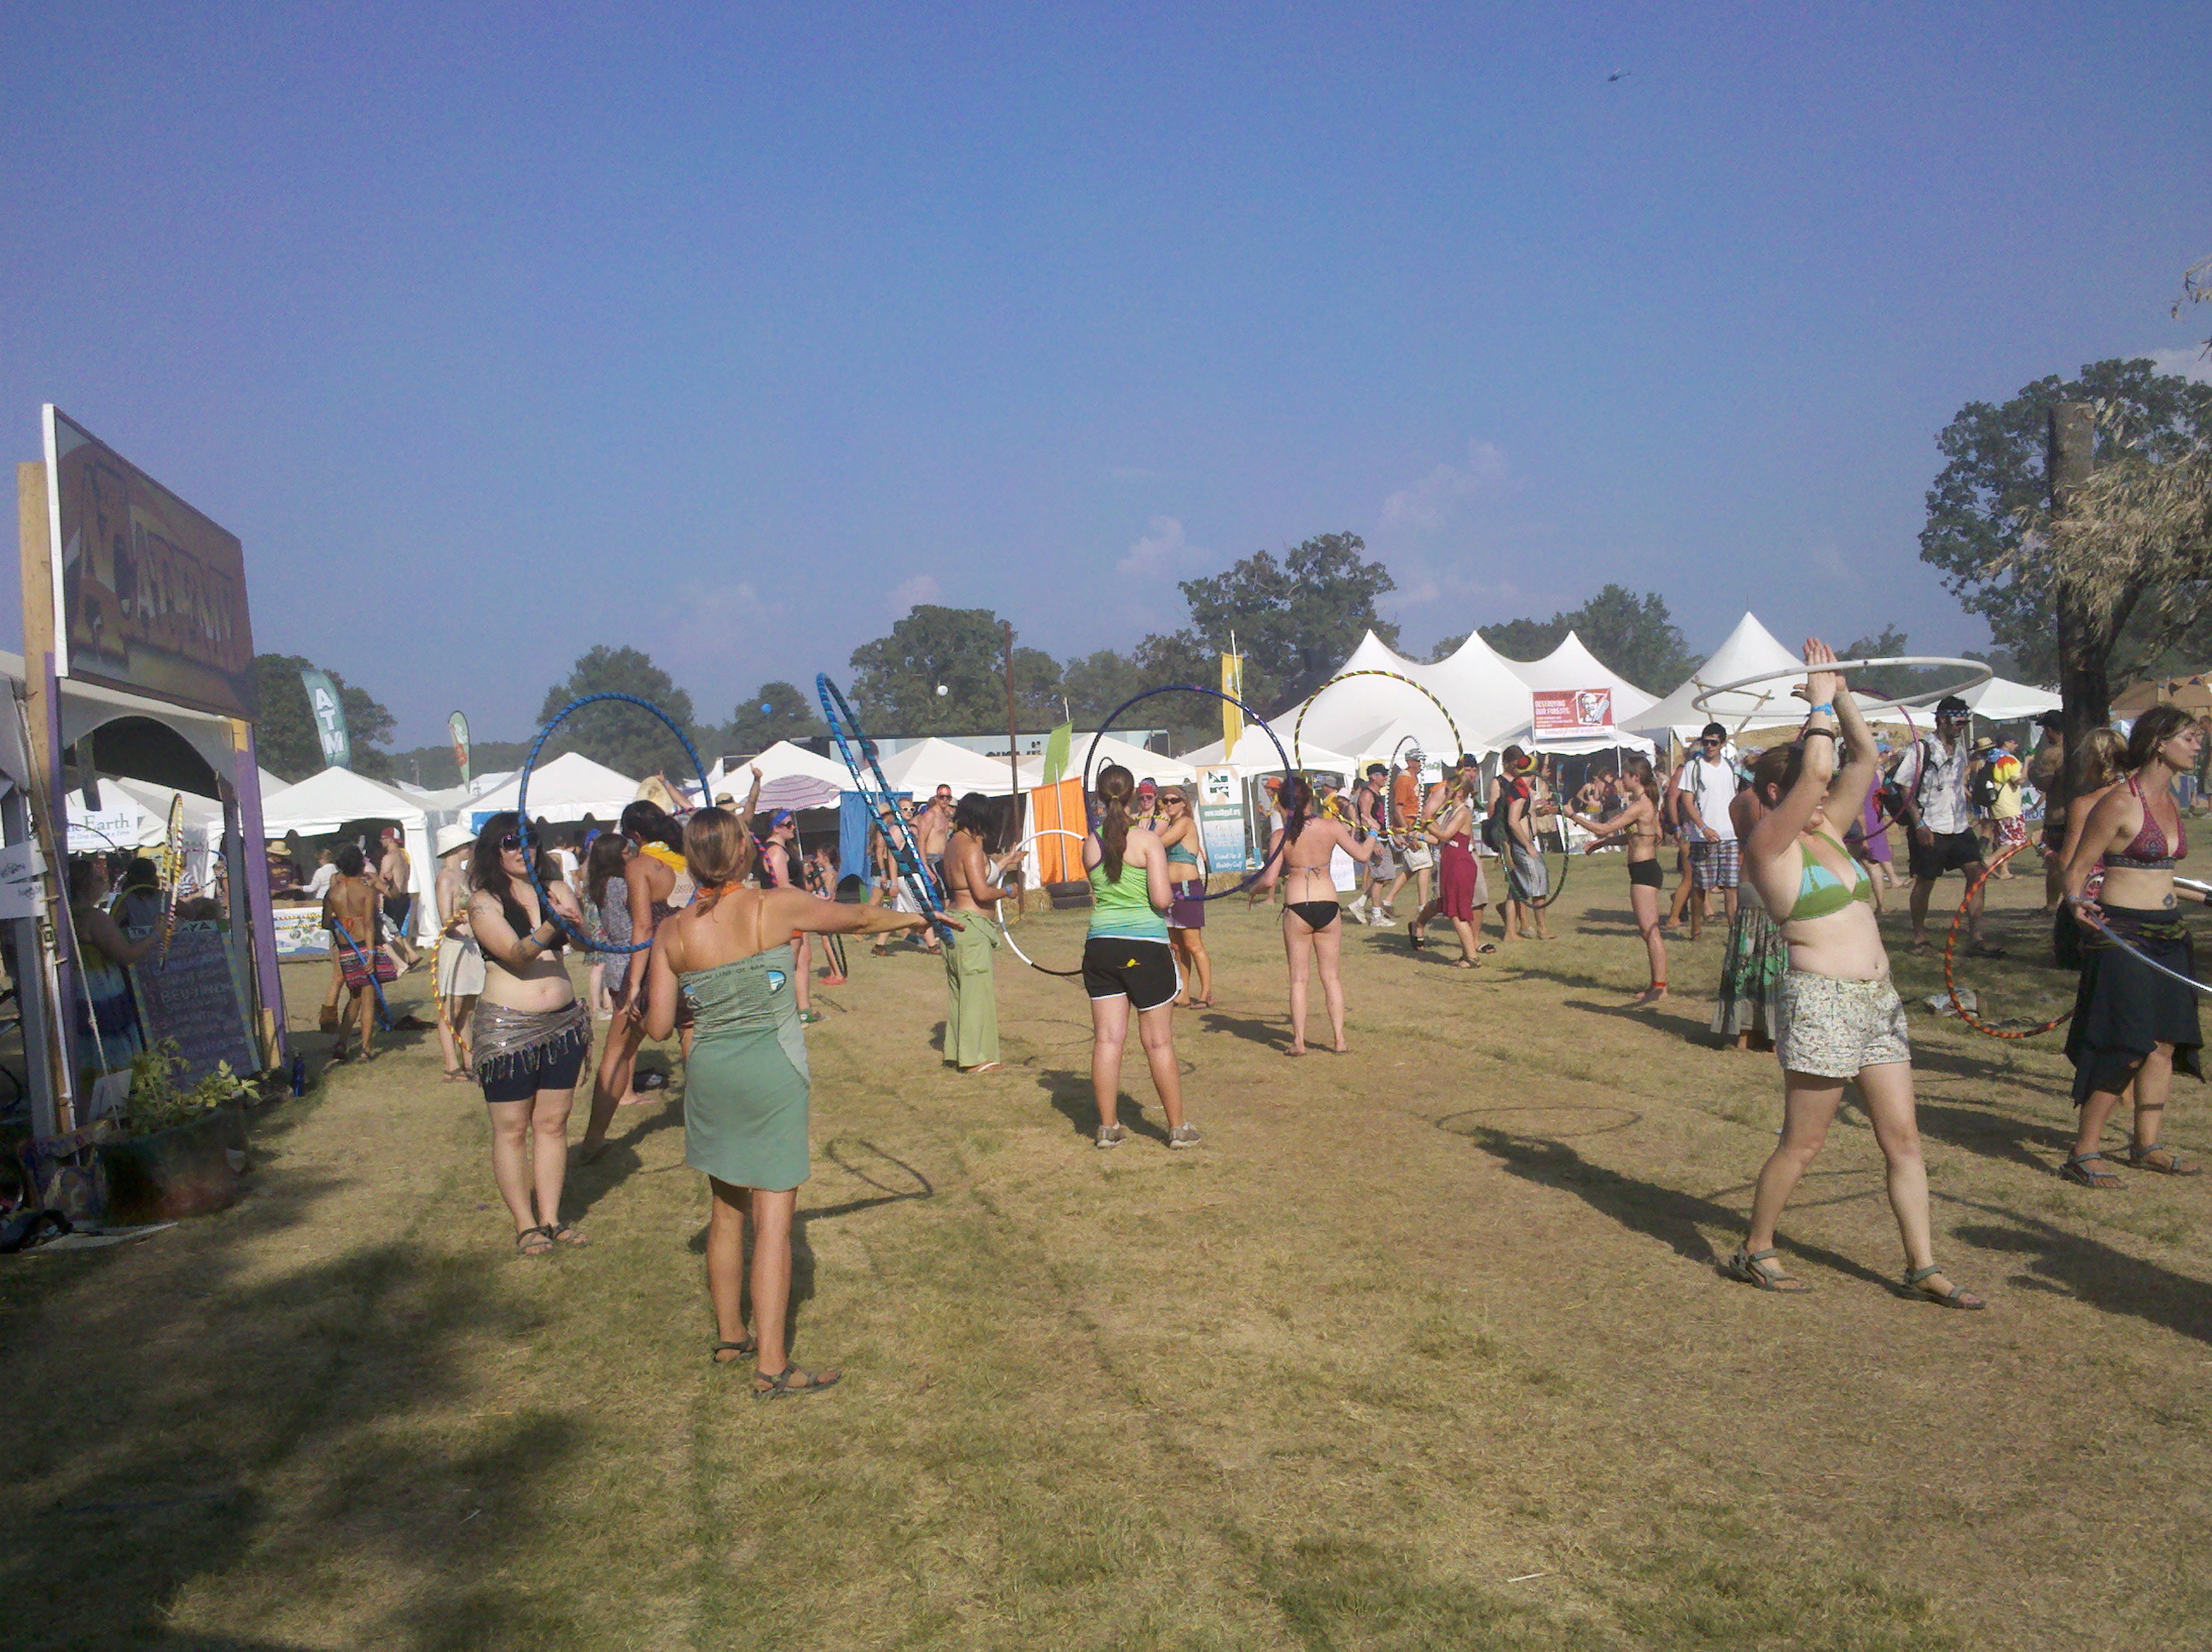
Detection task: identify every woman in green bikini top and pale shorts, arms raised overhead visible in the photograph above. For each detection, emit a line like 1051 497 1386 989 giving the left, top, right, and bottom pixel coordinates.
1727 642 1984 1307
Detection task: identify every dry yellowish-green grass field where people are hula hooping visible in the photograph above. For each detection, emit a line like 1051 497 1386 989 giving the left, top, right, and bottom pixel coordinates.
0 856 2212 1652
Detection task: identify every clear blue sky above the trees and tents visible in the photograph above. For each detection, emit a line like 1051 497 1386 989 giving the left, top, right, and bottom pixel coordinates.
0 3 2212 743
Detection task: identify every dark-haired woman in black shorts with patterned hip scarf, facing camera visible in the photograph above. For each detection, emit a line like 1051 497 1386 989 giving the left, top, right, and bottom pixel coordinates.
469 811 591 1256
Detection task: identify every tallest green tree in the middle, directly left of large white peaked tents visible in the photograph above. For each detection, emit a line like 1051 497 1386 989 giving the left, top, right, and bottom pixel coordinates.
1176 533 1398 710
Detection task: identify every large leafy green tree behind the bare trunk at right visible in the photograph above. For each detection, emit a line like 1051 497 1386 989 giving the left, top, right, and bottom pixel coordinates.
1920 360 2212 681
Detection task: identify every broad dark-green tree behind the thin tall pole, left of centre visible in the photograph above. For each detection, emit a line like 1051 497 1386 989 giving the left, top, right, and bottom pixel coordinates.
852 604 1060 736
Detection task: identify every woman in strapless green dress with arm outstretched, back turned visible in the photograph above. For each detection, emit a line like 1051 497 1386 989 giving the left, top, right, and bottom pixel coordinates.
646 810 929 1398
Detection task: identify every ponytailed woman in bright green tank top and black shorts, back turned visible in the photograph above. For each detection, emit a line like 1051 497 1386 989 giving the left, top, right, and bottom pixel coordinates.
1084 763 1199 1148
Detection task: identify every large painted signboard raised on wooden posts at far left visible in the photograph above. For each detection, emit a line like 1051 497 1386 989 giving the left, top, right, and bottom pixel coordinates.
46 404 259 718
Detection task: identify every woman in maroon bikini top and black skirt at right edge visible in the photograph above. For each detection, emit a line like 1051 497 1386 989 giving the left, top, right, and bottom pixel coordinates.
2059 706 2203 1188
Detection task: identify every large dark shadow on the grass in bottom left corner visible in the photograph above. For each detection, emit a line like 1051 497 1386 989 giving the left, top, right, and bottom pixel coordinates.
0 1177 578 1652
